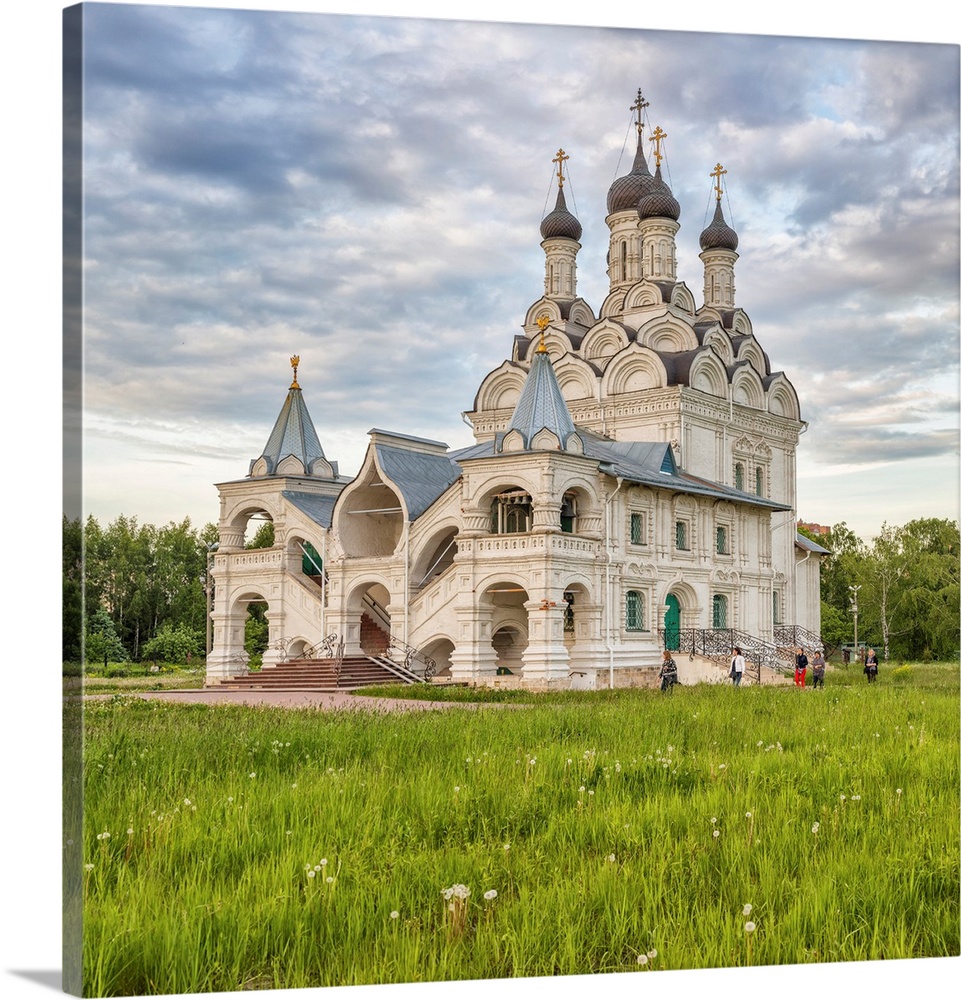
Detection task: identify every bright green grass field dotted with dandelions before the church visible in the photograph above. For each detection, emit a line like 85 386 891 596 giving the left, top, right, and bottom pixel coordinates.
73 664 961 996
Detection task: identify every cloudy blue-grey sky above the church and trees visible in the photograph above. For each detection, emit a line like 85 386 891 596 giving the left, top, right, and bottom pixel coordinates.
63 4 958 548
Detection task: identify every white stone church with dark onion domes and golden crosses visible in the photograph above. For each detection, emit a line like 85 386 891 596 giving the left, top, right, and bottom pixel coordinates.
207 91 825 690
